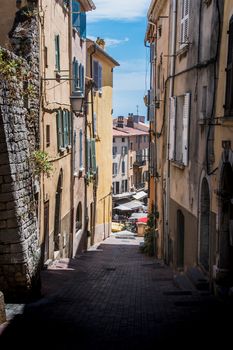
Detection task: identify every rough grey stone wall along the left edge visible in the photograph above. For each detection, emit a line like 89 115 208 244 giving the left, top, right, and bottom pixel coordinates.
0 10 40 300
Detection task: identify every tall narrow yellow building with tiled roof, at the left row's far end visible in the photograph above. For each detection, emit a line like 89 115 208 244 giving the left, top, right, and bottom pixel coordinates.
86 39 119 244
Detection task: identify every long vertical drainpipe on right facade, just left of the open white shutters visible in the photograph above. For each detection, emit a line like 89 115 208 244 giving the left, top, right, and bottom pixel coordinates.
164 0 177 264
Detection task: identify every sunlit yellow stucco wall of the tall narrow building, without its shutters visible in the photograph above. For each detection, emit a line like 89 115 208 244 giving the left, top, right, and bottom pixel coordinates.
87 43 117 241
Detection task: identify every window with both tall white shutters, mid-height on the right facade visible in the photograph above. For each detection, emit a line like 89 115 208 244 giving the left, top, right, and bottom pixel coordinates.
169 93 191 166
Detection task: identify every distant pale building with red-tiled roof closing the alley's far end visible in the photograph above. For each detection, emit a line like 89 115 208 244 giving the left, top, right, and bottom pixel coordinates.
112 115 149 195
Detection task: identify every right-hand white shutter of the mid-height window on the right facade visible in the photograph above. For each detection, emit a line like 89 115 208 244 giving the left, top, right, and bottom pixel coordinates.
182 92 191 166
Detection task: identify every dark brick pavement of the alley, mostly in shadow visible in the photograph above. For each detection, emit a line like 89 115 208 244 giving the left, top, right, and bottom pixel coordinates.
0 238 232 350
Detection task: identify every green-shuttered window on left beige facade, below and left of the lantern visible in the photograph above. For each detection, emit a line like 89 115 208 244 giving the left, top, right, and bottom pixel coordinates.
57 109 71 150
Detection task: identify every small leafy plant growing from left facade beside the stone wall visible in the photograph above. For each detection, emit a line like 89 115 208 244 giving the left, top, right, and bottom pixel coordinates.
31 150 53 175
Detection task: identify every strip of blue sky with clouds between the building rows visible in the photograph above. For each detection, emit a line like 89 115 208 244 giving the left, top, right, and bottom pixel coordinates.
87 0 151 117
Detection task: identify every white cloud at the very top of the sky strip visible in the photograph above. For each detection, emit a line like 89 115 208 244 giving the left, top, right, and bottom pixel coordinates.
88 0 151 22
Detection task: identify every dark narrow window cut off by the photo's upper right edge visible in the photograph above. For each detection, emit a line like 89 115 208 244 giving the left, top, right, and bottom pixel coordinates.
224 16 233 116
